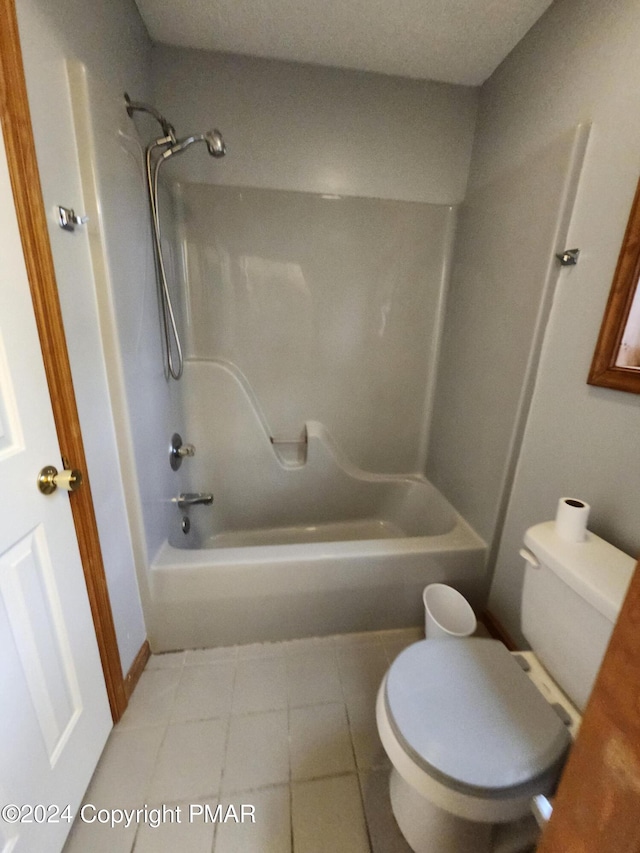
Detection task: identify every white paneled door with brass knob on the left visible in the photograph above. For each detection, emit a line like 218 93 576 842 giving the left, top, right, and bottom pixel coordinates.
0 134 112 853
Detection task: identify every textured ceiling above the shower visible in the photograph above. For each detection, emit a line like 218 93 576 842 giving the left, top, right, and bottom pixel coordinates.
136 0 551 86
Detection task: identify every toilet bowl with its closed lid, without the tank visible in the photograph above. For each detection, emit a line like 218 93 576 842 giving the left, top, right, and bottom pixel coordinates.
376 638 571 853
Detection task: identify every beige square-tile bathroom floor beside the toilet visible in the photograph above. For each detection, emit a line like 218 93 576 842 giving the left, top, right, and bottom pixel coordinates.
65 628 424 853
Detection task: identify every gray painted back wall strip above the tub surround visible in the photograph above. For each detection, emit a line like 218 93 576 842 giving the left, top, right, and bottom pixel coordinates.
153 45 477 204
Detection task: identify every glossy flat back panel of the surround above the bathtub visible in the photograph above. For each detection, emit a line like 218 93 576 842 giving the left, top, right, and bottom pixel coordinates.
176 185 455 474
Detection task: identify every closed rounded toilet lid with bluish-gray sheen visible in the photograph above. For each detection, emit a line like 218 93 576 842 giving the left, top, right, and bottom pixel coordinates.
385 638 571 796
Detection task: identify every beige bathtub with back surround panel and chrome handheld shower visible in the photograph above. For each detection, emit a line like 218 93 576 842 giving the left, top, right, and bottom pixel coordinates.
127 95 485 651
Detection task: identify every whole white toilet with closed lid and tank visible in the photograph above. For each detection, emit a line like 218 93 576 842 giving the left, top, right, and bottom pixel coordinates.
376 522 634 853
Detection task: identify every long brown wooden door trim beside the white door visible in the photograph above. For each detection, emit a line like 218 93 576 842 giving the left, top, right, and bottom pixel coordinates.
0 0 127 722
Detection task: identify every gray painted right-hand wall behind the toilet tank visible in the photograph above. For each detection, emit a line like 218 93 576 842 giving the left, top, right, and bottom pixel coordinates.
430 0 640 638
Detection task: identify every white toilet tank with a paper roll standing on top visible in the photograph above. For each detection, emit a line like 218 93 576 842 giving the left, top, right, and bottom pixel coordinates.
522 521 635 710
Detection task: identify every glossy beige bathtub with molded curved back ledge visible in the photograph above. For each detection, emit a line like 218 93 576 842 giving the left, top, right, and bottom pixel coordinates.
149 410 486 651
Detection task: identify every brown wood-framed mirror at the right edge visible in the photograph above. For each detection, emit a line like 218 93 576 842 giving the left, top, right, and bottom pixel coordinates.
587 181 640 394
